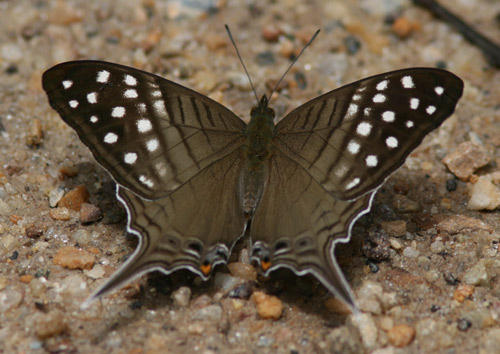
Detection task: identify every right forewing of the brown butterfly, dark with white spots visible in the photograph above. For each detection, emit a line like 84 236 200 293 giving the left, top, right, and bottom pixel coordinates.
276 68 463 199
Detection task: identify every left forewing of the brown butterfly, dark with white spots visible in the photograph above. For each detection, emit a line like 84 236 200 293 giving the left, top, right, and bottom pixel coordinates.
42 61 245 199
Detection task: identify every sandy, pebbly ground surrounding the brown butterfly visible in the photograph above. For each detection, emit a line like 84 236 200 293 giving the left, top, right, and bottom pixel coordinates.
0 0 500 354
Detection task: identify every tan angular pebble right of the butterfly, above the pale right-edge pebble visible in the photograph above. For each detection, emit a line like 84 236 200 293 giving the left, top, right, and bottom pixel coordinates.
443 141 490 181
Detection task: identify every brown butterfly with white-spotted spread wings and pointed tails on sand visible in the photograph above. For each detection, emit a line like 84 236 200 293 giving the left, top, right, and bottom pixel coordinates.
42 48 463 309
